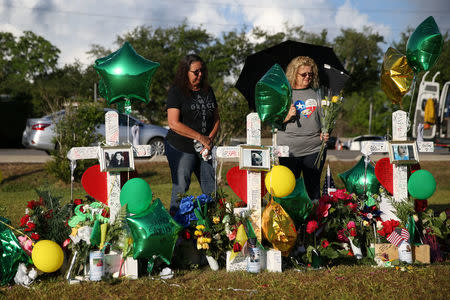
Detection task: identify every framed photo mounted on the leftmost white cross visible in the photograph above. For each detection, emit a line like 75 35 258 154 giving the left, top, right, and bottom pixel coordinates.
100 146 134 172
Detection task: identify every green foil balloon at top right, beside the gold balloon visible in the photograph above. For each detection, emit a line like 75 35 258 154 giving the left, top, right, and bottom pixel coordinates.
406 17 444 73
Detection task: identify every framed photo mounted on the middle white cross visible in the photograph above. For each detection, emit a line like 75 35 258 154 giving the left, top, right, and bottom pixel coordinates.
239 145 270 171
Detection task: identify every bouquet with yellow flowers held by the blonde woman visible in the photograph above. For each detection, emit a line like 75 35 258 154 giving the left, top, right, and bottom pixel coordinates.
314 96 344 168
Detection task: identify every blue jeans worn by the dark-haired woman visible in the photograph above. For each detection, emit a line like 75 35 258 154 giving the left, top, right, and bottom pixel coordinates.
165 141 215 215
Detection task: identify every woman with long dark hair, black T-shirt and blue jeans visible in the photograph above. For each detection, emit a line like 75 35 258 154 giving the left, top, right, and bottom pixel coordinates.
165 54 220 215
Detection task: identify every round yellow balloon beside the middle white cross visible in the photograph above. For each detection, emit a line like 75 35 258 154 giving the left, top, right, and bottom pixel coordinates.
265 165 295 198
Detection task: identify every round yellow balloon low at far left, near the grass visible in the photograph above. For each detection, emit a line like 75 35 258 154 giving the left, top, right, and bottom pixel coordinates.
31 240 64 273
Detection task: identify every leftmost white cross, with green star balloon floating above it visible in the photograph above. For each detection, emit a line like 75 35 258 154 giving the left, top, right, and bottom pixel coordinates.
67 111 150 223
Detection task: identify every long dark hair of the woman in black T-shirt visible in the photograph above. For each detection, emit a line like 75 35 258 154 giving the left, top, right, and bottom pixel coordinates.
173 54 209 96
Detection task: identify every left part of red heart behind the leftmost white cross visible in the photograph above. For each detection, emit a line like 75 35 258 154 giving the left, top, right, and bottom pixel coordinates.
81 165 108 205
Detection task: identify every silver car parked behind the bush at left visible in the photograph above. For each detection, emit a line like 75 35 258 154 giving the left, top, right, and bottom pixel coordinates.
22 108 168 157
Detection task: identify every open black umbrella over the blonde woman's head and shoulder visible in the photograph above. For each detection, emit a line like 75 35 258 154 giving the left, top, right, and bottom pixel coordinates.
236 41 346 110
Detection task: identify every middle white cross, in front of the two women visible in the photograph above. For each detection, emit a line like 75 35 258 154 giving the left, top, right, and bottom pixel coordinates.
216 113 289 241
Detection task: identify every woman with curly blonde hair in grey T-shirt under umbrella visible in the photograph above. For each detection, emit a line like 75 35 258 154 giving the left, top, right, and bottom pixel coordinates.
278 56 329 200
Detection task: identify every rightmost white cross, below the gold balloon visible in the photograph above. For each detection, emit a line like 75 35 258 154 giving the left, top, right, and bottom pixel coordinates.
361 110 434 220
